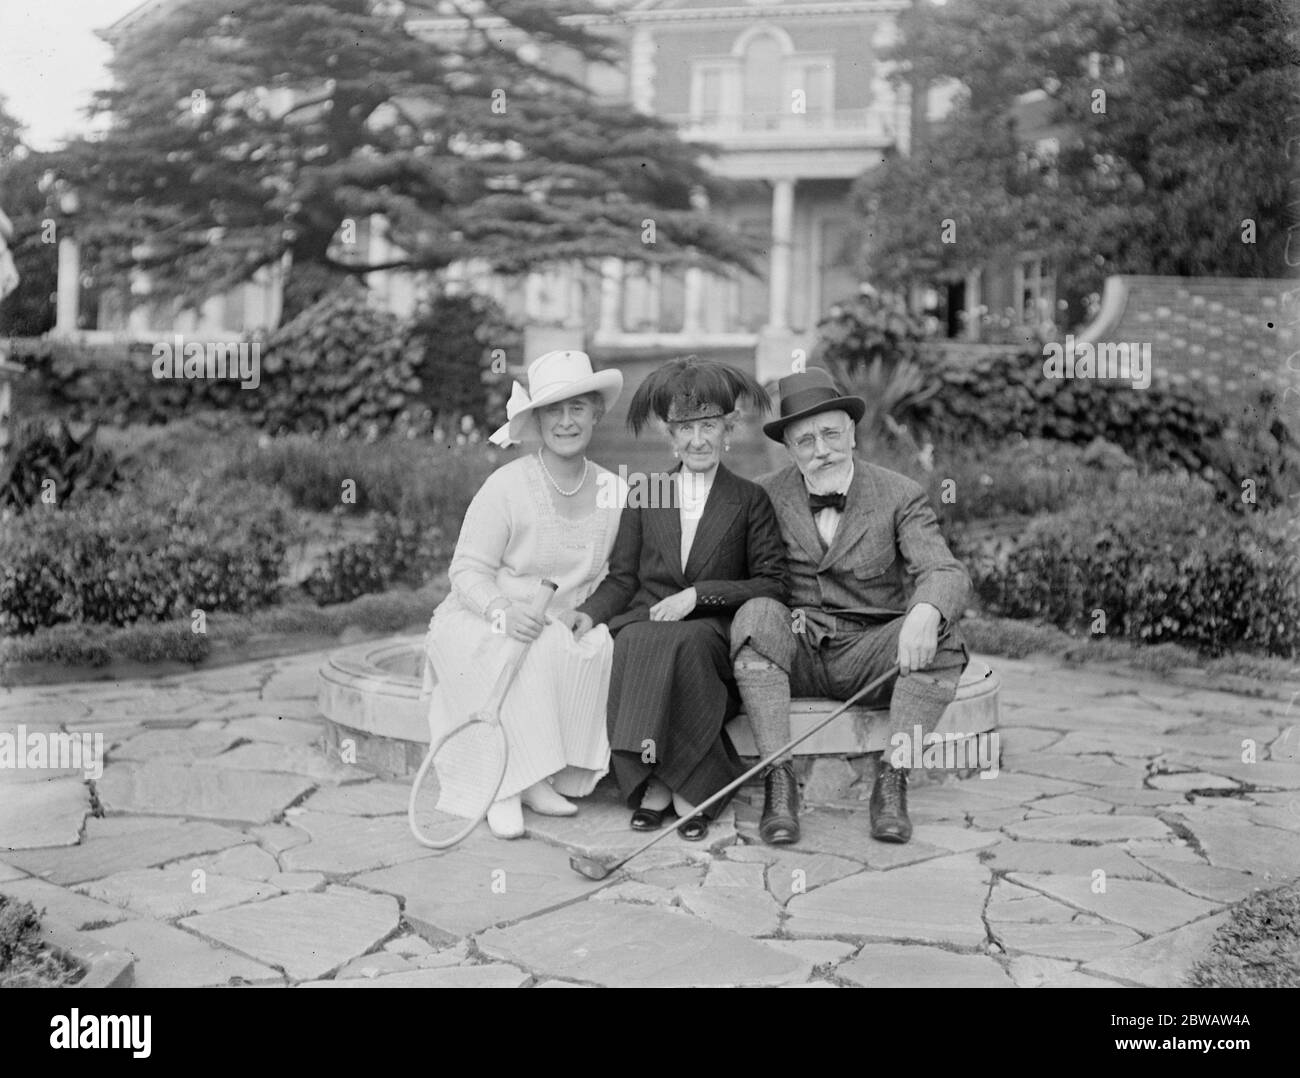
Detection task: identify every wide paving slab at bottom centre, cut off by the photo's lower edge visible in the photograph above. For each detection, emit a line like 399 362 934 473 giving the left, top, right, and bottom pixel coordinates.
478 902 813 988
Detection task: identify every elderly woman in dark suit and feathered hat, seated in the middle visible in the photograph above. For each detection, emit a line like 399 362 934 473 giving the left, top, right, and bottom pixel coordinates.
556 356 789 840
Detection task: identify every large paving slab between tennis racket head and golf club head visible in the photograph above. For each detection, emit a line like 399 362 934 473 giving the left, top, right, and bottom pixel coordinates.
352 839 612 941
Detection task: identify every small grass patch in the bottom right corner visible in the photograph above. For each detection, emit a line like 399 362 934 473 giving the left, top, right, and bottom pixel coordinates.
1187 883 1300 988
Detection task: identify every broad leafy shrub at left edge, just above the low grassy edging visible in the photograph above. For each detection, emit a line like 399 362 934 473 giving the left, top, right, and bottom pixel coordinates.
0 477 294 633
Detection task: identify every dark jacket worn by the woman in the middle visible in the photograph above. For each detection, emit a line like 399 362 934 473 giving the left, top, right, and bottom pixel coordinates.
577 464 789 632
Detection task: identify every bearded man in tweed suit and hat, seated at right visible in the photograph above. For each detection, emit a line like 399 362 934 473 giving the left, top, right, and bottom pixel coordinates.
731 367 971 845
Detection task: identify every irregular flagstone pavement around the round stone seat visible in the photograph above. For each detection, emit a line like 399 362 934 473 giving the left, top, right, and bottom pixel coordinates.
0 642 1300 988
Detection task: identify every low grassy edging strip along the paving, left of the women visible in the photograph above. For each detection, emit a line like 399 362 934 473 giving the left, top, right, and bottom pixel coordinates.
0 576 447 680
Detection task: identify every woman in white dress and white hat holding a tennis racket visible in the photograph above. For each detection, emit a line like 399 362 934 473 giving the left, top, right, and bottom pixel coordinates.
425 351 625 839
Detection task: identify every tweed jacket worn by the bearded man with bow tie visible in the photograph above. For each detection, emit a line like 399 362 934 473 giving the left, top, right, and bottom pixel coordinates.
758 459 971 644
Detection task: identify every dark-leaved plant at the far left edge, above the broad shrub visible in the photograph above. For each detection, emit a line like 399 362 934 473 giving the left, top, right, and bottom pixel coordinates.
0 420 121 512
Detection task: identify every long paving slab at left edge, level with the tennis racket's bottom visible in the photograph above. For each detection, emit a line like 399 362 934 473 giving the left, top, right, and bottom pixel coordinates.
8 819 248 886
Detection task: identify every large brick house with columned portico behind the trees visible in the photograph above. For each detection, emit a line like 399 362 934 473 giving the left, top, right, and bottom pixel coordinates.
76 0 911 375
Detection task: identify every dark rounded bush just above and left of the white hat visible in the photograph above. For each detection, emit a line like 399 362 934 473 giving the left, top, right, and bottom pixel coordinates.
408 293 524 428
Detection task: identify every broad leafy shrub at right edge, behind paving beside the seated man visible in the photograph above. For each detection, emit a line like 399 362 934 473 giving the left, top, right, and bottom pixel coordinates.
962 477 1300 658
